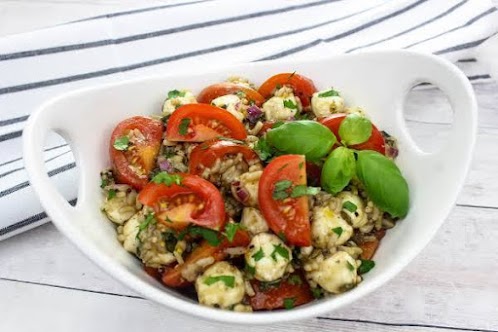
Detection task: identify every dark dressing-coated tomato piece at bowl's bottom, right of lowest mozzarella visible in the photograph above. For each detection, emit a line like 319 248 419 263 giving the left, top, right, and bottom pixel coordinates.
249 273 314 310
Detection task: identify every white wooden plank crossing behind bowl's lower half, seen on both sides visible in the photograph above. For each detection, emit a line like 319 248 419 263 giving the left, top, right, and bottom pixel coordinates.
0 207 498 330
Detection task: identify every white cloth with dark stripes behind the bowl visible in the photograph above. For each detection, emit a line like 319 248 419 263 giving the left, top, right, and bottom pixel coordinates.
0 0 498 239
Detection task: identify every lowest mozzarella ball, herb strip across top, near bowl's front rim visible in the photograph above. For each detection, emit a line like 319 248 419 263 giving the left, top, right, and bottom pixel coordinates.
195 262 245 308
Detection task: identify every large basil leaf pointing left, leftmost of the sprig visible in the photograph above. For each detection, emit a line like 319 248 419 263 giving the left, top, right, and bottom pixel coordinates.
266 120 337 161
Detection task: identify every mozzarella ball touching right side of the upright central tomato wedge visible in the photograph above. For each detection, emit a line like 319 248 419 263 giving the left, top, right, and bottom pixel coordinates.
311 206 353 249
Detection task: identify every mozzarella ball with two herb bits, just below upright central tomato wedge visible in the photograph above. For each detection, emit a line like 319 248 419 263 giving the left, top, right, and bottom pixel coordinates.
245 233 292 281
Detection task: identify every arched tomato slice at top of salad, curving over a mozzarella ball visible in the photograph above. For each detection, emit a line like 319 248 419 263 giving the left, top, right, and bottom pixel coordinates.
258 73 317 107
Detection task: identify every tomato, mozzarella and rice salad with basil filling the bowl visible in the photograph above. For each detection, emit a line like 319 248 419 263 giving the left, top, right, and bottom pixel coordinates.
101 72 409 312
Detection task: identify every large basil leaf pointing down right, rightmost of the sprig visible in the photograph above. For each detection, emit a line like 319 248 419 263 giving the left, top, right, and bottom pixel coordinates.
356 150 409 218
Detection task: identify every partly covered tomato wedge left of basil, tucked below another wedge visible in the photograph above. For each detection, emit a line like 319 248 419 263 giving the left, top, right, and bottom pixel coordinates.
189 140 259 175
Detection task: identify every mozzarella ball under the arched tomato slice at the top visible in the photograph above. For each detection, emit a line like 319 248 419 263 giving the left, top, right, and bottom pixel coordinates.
263 86 301 121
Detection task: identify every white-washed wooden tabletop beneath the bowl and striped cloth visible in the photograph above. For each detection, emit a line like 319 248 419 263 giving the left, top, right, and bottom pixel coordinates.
0 0 498 331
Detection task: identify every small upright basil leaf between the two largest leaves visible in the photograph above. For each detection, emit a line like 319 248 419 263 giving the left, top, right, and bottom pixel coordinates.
321 146 355 194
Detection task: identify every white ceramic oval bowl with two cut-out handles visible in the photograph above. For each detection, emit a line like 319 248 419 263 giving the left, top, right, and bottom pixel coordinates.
23 51 477 324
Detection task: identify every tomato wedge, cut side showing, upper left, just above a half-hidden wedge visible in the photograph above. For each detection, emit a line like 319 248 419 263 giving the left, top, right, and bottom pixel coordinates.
166 104 247 142
